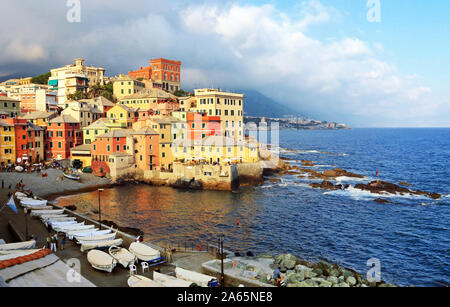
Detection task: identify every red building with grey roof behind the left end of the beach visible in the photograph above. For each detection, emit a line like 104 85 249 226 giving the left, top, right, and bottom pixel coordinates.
45 115 83 160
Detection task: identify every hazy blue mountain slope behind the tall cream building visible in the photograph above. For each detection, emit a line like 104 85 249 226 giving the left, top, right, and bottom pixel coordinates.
236 90 301 118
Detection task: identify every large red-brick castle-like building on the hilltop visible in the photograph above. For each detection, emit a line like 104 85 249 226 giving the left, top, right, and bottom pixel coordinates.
128 58 181 92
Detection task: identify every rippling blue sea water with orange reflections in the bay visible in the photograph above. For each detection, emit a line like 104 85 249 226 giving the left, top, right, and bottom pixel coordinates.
58 129 450 286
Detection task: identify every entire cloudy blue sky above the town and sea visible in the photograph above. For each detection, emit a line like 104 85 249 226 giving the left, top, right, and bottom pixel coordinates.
0 0 450 127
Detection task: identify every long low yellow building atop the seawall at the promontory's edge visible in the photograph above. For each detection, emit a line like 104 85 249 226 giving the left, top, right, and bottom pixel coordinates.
173 136 259 164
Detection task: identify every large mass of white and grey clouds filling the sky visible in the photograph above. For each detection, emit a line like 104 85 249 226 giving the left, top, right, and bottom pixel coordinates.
0 0 450 125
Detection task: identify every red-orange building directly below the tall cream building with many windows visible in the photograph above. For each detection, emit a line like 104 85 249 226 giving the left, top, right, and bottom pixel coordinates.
186 113 222 140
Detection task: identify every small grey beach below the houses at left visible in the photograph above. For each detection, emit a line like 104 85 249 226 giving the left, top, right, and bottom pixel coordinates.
0 169 111 197
